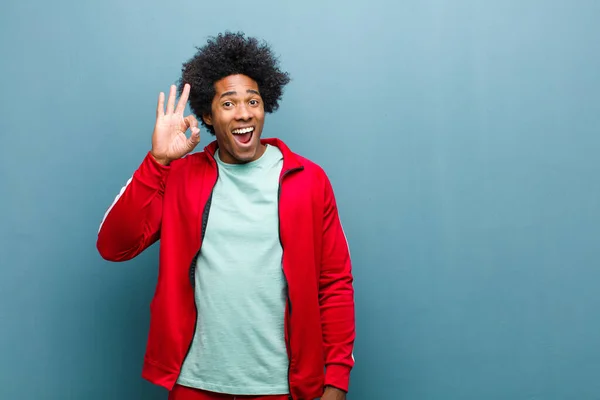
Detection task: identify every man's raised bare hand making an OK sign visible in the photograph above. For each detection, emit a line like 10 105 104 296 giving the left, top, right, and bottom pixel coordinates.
150 83 200 165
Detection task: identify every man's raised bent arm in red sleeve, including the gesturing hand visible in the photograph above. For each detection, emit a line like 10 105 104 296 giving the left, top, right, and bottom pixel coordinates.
96 84 200 261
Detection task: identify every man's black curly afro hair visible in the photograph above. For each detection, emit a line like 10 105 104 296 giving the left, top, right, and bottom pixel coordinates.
179 32 290 135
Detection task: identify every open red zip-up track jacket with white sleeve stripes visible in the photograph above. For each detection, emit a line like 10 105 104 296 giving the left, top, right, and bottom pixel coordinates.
97 139 355 400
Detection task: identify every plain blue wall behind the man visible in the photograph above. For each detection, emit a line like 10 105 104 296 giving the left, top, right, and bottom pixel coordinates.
0 0 600 400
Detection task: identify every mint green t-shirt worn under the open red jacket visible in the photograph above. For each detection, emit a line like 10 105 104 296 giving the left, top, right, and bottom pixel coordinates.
177 146 289 395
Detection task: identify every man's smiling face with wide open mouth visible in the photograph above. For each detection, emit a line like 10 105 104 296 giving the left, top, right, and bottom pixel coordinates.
203 75 265 164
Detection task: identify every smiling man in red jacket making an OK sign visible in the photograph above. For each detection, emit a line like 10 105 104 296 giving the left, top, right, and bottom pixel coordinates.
97 33 355 400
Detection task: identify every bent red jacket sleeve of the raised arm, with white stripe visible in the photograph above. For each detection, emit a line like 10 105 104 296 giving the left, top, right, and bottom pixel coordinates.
96 152 171 261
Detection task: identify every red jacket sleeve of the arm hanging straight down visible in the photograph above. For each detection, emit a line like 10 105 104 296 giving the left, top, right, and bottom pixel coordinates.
319 174 355 392
